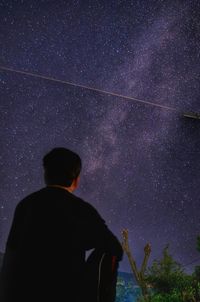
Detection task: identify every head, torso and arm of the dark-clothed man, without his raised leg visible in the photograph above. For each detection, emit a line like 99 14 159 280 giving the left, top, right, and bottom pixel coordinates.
1 148 123 302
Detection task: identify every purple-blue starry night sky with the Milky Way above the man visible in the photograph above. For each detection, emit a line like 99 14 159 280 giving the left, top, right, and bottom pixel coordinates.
0 0 200 271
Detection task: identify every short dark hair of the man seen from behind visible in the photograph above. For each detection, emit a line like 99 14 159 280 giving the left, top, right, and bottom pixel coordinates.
43 148 82 187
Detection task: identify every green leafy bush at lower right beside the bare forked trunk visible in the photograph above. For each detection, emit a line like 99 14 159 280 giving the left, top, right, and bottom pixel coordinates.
140 246 196 302
